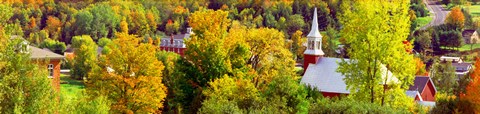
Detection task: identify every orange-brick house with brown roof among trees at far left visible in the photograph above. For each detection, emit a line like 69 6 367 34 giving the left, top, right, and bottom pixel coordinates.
27 46 65 91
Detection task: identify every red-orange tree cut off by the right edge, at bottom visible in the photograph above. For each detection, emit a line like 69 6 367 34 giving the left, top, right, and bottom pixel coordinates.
460 57 480 113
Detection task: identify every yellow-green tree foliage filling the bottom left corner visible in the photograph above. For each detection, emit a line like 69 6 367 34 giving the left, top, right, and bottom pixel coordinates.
0 37 58 113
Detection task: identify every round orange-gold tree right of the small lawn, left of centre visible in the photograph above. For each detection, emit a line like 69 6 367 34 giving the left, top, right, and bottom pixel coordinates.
86 33 167 113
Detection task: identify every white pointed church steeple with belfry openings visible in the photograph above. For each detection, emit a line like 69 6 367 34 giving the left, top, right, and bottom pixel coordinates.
303 8 325 56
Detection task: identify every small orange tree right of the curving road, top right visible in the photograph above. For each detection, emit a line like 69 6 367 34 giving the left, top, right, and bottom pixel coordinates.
445 7 465 29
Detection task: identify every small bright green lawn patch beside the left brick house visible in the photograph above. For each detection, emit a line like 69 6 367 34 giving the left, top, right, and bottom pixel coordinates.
60 74 85 99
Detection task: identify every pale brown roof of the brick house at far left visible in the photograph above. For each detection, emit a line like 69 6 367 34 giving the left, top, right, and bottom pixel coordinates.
29 46 65 59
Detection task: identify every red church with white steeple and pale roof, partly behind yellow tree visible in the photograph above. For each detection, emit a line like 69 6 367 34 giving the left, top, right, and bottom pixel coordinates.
301 9 398 97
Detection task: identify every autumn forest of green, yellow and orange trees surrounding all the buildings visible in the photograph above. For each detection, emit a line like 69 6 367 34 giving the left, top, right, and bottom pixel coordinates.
0 0 480 114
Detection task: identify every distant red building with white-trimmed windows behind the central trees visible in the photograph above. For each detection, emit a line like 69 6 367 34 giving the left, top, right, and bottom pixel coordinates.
160 28 193 56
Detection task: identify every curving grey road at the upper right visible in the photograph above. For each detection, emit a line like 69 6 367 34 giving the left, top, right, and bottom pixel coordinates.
421 0 450 30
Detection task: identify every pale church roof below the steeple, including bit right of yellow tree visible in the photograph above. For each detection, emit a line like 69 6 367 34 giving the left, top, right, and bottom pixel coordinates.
300 57 398 94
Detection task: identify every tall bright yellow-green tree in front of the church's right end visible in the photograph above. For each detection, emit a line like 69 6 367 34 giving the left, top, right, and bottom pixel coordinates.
337 0 415 108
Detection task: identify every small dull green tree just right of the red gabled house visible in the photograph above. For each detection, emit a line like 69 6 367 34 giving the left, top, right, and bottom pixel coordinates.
432 62 458 95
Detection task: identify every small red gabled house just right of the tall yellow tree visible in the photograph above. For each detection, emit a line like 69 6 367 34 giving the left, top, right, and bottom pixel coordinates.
407 76 437 102
